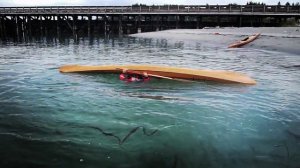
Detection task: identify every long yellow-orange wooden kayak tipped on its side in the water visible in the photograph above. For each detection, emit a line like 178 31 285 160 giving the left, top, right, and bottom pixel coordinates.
59 65 256 85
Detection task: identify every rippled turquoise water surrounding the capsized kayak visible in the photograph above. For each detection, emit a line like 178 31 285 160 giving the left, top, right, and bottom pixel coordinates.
0 36 300 168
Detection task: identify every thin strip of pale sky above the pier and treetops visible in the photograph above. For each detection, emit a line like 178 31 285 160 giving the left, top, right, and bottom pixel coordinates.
0 0 299 7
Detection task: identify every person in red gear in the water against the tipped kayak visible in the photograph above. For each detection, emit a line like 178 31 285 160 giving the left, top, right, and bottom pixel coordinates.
120 69 150 82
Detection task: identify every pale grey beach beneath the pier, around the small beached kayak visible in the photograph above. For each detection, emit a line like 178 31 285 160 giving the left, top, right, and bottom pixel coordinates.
129 27 300 54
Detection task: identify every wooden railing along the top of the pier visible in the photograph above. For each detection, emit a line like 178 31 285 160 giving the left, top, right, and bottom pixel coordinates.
0 5 300 15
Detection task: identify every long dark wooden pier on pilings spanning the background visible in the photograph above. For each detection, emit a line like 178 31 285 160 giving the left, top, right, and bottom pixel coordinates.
0 5 300 39
